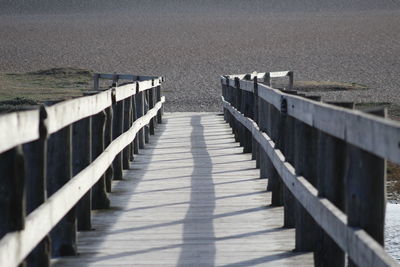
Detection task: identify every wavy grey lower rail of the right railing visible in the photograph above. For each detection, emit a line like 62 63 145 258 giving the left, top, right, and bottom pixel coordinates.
222 97 398 266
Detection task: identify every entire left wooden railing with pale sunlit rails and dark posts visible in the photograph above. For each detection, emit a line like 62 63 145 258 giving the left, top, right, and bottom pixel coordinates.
0 74 165 267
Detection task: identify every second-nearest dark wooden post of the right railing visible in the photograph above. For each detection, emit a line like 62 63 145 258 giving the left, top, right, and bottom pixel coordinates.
314 102 354 267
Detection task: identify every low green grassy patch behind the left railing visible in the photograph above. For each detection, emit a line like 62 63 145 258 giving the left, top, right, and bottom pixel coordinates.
0 68 93 112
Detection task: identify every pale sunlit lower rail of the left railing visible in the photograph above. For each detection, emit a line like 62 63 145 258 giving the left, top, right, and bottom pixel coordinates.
0 97 165 267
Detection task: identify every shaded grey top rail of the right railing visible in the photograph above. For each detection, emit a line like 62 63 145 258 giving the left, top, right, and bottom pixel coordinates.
221 77 400 164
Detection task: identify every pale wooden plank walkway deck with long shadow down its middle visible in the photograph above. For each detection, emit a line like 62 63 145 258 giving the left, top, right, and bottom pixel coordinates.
54 113 313 266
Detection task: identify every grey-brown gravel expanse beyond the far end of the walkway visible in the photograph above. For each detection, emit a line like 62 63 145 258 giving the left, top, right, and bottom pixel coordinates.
0 0 400 111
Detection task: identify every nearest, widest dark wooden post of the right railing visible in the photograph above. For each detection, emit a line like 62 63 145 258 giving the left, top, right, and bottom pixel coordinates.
345 108 387 266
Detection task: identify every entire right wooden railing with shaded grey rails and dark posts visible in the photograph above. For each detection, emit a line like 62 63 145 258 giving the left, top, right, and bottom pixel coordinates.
221 72 400 266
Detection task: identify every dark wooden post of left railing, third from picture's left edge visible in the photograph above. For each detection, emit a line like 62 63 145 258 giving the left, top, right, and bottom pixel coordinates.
47 126 76 257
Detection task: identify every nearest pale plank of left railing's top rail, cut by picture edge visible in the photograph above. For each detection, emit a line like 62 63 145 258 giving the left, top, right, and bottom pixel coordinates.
0 110 39 153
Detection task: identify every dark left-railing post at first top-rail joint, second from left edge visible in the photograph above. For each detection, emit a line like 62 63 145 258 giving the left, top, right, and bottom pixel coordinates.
23 106 50 267
